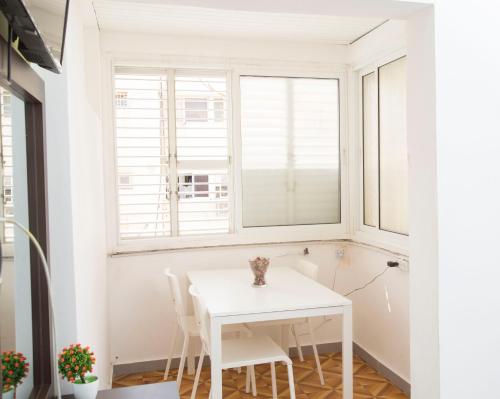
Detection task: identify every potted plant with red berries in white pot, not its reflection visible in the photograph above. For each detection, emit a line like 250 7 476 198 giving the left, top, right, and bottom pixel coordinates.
59 344 98 399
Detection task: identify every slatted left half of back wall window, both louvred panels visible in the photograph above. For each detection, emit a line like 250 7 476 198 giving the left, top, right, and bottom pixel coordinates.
114 67 230 240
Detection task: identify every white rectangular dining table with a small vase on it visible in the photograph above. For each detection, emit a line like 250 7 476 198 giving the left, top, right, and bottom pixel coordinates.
187 267 353 399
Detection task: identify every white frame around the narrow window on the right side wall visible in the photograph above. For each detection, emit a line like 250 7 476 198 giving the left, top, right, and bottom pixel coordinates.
351 49 409 254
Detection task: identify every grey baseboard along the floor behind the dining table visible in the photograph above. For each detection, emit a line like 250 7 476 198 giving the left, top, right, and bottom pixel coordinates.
113 342 411 397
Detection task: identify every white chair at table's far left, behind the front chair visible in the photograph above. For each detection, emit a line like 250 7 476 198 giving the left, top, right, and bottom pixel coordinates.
163 268 251 387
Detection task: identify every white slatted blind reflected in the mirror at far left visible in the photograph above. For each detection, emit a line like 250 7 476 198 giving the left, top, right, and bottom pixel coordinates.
0 88 14 243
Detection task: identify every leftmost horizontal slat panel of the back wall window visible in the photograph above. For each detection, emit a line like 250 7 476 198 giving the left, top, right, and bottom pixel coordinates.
114 68 171 240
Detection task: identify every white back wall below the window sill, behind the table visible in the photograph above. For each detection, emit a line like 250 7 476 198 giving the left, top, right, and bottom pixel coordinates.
109 244 340 363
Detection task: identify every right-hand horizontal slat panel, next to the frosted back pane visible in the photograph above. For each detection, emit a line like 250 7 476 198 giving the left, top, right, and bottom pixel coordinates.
175 72 229 235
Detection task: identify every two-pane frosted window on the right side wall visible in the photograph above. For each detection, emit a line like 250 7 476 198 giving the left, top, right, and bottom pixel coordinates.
361 57 408 235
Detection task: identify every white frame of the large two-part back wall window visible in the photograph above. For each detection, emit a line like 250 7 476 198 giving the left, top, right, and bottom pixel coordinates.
102 54 351 254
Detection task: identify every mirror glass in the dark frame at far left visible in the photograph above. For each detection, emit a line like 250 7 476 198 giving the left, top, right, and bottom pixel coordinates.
0 88 34 399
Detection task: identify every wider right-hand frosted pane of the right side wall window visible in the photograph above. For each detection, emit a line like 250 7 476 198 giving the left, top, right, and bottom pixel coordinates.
379 58 408 234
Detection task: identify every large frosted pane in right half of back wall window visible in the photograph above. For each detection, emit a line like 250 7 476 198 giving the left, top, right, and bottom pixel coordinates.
240 76 340 227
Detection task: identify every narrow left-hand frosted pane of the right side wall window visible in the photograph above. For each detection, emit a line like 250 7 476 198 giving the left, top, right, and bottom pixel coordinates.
363 72 378 227
